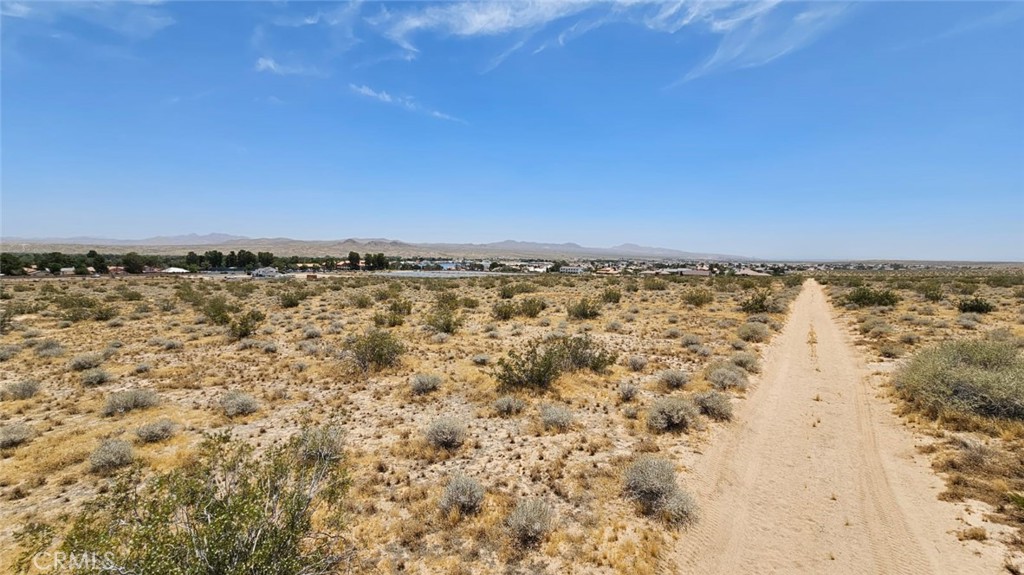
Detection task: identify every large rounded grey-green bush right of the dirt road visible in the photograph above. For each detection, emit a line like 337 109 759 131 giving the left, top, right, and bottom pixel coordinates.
893 340 1024 419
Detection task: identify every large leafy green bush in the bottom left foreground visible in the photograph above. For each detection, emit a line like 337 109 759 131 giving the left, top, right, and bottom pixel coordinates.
23 427 348 575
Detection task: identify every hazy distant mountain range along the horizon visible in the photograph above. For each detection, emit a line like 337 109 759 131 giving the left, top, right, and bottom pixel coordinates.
0 233 752 261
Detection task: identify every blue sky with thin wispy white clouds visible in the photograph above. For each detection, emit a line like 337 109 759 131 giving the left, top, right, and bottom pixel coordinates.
0 0 1024 261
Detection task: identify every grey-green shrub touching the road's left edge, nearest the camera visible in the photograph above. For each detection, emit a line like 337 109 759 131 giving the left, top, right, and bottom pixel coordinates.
623 455 697 526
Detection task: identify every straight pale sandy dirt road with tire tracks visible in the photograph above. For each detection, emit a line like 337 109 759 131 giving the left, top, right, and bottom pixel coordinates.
675 280 1002 574
